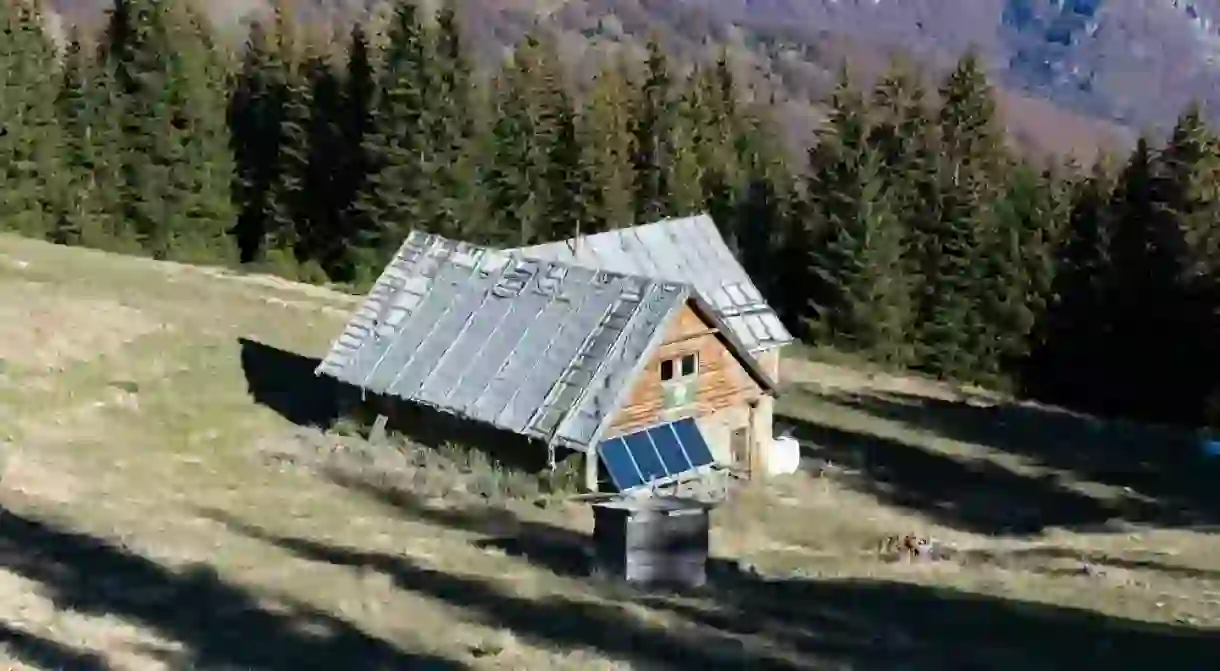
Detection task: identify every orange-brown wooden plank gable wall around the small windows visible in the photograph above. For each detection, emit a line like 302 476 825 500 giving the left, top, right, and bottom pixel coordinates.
606 304 763 438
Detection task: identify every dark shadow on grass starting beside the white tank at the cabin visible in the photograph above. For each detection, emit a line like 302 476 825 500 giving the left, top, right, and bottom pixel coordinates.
781 407 1142 536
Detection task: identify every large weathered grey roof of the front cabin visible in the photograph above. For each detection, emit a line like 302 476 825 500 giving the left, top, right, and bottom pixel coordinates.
316 232 773 450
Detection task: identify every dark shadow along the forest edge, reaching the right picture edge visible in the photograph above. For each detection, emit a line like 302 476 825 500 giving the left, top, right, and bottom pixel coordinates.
832 393 1220 528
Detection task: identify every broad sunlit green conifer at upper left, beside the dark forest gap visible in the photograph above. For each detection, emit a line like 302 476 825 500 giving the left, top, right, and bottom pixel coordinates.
104 0 235 262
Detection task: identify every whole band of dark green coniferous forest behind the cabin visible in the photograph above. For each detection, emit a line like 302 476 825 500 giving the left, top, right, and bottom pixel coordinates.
0 0 1220 431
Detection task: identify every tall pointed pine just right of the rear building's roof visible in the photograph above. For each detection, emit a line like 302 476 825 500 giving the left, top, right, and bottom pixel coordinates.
810 77 911 362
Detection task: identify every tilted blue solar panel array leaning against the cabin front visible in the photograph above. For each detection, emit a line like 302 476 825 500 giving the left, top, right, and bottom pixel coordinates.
598 418 714 492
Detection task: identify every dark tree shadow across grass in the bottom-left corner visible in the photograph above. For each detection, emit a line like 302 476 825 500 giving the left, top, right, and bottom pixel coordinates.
0 511 465 671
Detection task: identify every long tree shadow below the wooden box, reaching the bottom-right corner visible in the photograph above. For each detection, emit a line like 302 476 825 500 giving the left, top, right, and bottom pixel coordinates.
209 490 1220 671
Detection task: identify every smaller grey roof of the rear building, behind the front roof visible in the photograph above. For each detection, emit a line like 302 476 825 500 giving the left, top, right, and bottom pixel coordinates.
511 215 793 353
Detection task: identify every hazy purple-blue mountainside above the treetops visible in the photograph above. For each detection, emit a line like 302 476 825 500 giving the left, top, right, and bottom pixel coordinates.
50 0 1220 159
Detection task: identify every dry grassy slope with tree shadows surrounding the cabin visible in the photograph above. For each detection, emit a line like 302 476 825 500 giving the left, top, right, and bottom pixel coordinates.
0 237 1220 670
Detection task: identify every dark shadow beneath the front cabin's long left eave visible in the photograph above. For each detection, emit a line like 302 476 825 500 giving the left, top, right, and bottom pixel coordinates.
238 338 548 473
